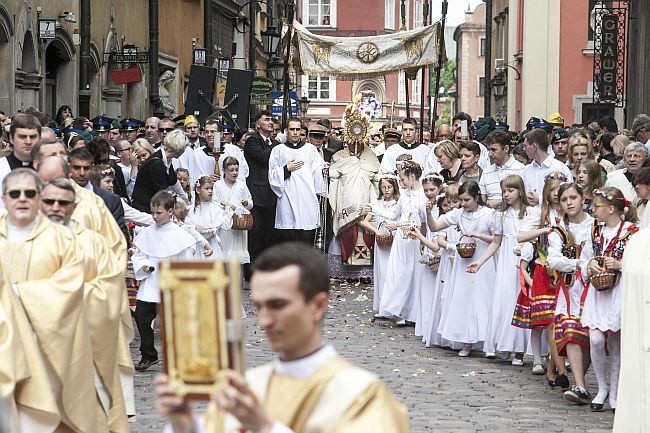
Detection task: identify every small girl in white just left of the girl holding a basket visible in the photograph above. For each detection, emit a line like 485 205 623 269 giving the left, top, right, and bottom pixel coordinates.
185 175 232 260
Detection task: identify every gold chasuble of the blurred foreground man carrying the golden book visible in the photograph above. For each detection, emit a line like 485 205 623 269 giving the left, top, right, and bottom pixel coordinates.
204 355 410 433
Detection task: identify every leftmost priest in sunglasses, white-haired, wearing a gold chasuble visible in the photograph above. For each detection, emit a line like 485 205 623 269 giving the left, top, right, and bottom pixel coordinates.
0 168 98 433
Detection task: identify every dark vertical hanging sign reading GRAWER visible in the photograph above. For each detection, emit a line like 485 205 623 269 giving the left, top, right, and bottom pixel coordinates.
600 14 619 102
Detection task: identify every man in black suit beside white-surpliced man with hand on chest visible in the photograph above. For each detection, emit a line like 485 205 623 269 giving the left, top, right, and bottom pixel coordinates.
244 110 277 279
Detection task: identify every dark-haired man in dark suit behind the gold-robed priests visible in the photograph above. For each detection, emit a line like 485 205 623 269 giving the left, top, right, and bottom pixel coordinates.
68 147 129 239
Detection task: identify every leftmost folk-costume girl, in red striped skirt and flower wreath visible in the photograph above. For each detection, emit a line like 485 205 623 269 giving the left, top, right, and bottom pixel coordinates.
512 171 569 389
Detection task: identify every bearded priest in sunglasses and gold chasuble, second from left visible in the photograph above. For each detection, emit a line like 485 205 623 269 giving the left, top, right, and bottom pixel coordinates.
40 179 128 431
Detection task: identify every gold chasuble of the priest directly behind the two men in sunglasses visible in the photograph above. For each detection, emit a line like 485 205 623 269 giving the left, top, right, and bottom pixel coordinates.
72 182 135 398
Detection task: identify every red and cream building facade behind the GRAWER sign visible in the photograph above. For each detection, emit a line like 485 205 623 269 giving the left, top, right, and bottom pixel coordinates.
489 0 628 130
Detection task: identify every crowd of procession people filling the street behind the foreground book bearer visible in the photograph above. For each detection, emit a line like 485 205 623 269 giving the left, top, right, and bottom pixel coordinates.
0 103 650 432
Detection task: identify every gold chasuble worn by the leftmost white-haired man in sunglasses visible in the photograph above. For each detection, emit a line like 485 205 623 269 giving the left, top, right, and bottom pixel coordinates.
0 214 98 433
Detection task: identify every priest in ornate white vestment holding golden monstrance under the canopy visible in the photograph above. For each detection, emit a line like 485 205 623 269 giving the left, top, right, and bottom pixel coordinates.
329 98 379 279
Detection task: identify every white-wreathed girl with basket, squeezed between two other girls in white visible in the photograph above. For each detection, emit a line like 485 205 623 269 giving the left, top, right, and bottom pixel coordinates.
411 173 443 341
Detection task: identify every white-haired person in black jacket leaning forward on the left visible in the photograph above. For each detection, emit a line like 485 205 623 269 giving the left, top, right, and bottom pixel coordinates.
131 130 187 213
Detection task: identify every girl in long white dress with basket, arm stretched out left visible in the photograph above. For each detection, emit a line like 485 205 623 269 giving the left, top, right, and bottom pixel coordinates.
429 181 498 357
